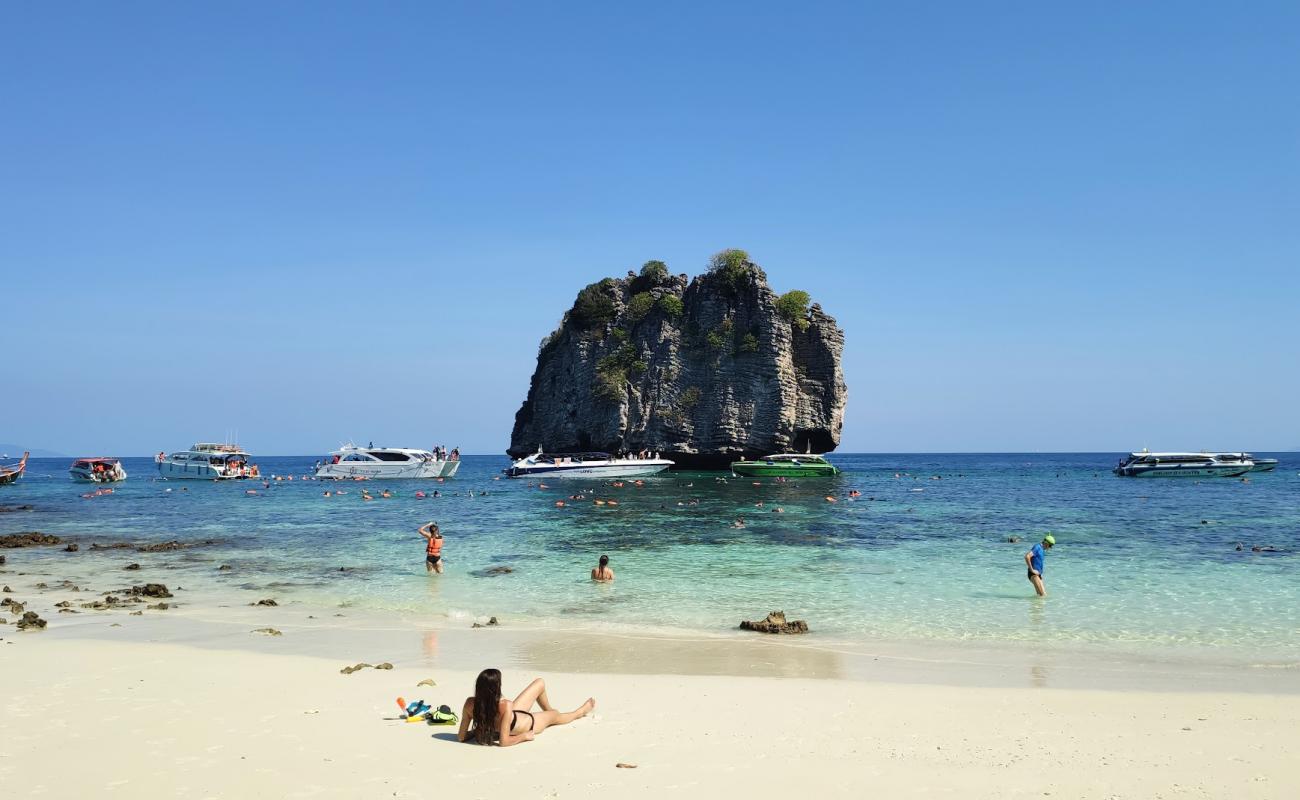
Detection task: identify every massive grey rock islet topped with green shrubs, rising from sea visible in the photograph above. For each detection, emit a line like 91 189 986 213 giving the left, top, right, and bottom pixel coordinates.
508 251 848 468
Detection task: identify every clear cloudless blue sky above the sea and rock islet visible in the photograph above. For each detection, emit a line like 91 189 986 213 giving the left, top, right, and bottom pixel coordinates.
0 1 1300 454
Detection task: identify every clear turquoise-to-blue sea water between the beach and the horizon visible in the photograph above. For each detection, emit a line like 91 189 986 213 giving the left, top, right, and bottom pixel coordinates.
0 454 1300 666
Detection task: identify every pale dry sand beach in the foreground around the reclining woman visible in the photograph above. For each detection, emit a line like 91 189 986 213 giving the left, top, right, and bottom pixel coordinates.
0 609 1300 799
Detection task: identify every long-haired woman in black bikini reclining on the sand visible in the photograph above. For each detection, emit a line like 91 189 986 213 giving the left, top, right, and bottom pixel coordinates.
456 669 595 747
